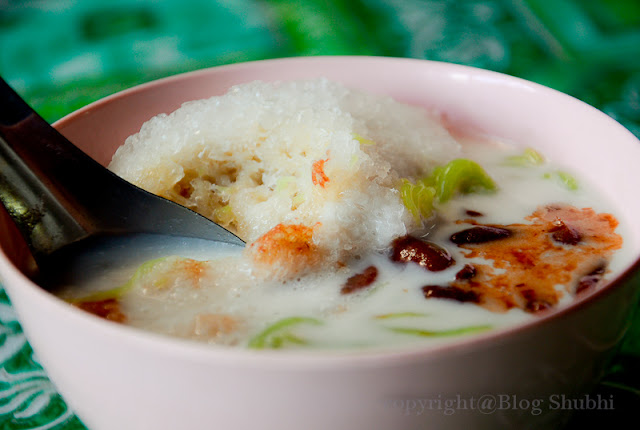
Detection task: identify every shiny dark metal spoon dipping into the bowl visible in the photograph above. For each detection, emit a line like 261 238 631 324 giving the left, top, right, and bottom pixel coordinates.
0 78 245 289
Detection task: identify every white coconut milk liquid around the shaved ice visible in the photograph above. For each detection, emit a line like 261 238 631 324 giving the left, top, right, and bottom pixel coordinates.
56 137 627 348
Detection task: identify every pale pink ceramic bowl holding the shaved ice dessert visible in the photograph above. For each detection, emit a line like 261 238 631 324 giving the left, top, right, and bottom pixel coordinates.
0 57 640 430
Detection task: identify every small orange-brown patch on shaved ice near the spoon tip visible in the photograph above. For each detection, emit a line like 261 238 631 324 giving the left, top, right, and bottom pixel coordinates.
251 223 321 273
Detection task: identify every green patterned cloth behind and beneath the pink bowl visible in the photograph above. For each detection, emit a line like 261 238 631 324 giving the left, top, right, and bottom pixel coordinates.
0 0 640 430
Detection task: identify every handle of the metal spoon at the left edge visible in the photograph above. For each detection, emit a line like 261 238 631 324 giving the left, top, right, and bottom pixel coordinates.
0 78 95 256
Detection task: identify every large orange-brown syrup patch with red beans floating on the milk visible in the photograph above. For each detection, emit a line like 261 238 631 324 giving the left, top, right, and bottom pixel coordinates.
442 206 622 312
